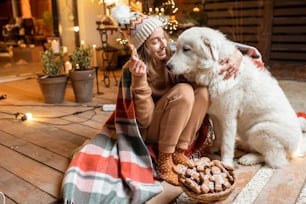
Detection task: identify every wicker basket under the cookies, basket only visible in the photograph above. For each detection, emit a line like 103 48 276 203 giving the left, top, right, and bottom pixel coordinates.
180 172 237 202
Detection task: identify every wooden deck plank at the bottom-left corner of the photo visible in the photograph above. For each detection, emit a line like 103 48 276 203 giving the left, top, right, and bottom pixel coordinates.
0 167 57 204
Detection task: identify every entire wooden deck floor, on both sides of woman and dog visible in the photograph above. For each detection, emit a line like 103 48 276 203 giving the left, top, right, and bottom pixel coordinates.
0 69 306 204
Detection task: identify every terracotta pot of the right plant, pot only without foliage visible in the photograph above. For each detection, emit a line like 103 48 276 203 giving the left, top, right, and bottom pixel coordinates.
69 69 96 103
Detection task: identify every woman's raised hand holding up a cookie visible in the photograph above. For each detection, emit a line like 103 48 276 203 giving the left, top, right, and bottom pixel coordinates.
129 44 147 76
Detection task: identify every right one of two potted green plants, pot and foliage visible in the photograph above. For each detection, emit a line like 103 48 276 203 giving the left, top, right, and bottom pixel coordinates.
69 44 96 103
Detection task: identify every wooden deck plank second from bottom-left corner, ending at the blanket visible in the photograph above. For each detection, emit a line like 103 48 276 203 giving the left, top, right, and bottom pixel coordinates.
0 146 63 198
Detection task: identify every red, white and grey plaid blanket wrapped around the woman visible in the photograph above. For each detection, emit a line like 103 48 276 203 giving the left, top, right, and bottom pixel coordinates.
62 69 212 204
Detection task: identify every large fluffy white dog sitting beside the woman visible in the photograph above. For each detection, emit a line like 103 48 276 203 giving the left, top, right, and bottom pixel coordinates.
167 27 302 168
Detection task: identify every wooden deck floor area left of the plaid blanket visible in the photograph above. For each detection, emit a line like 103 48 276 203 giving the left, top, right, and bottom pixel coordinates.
0 69 117 204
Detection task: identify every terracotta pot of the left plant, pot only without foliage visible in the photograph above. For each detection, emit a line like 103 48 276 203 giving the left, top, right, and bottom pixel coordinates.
38 76 68 104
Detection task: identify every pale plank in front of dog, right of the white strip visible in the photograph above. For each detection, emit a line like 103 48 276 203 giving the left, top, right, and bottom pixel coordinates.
254 157 306 204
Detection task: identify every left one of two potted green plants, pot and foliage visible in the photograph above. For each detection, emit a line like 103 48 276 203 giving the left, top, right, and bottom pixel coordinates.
38 48 68 104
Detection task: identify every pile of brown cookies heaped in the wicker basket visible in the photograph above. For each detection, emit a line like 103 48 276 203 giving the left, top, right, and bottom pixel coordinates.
174 157 235 194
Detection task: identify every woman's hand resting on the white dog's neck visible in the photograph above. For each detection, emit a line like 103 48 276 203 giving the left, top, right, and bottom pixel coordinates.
220 49 242 79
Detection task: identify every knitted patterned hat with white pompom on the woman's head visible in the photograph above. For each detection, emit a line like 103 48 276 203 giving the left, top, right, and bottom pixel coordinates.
111 5 163 49
